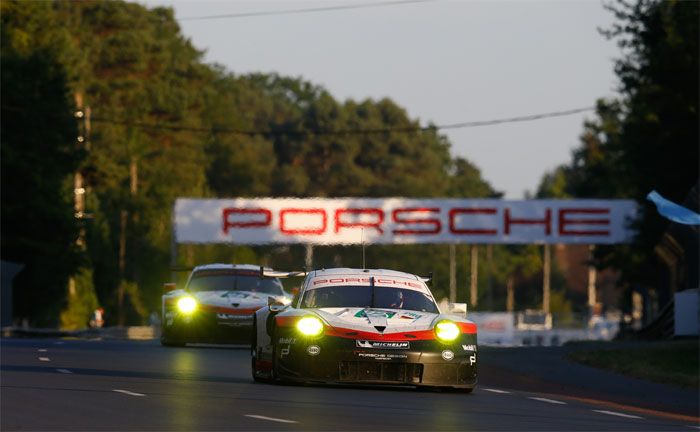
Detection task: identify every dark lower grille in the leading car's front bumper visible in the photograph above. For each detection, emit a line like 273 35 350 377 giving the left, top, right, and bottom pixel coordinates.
339 361 423 384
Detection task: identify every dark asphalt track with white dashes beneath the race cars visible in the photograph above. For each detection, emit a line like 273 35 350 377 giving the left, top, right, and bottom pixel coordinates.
0 339 700 431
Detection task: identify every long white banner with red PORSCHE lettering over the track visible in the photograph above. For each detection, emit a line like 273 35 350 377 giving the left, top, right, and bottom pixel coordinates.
175 198 637 245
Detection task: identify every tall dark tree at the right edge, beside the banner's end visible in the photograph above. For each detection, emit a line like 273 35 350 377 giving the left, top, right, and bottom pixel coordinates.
538 0 700 301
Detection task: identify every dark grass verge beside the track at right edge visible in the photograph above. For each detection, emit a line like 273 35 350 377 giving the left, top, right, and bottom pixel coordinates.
567 339 700 389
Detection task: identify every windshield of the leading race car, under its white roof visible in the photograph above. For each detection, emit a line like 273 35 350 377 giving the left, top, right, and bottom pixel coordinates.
301 285 438 313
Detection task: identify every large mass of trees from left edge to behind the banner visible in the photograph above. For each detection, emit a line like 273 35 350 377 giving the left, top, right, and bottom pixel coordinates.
0 0 499 326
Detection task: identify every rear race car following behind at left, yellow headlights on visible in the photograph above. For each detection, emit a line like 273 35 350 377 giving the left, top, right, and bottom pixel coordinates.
160 264 292 346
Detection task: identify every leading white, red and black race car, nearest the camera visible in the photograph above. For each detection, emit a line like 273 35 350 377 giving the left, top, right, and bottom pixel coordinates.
251 268 477 392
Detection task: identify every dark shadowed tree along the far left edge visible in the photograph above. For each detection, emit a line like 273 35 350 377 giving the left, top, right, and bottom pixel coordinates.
0 2 84 325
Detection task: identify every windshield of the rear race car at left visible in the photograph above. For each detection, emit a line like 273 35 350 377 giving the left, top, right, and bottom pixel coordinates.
187 270 284 295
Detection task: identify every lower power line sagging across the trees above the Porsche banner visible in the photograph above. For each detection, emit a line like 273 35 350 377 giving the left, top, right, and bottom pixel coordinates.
92 107 595 136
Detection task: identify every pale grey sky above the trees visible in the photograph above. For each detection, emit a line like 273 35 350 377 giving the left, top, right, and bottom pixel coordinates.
140 0 620 199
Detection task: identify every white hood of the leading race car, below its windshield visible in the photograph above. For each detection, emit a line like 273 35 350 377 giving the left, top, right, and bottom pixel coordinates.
315 307 438 333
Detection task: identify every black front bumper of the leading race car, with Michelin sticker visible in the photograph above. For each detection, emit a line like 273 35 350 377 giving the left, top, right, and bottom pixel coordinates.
274 334 477 388
